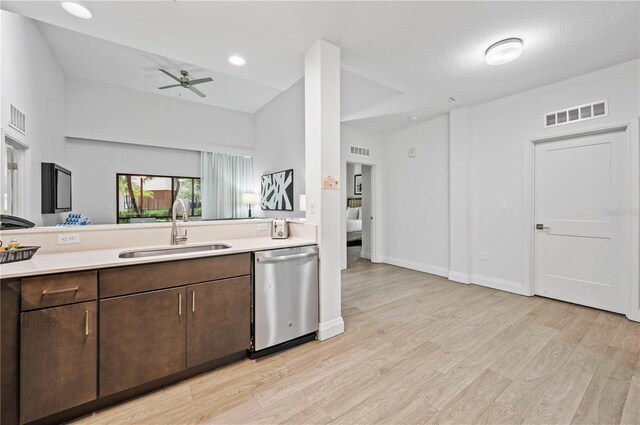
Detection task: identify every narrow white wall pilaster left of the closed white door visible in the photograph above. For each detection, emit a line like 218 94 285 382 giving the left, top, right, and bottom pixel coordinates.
449 107 471 283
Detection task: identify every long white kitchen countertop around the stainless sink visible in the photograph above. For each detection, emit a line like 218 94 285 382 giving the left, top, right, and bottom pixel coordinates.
0 237 315 279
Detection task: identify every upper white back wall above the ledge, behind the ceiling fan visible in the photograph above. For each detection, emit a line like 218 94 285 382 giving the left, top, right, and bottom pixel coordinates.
65 76 253 154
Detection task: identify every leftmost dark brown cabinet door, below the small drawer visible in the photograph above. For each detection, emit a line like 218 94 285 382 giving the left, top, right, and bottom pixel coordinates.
20 301 98 423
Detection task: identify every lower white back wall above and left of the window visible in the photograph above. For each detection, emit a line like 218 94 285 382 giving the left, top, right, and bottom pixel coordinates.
67 139 200 224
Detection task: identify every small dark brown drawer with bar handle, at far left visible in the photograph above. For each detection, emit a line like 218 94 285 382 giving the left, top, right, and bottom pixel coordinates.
22 270 97 311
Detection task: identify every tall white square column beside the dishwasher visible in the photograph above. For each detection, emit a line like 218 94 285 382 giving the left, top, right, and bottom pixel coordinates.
304 40 344 341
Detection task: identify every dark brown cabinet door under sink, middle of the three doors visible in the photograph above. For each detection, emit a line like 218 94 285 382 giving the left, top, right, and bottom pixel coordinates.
99 288 187 397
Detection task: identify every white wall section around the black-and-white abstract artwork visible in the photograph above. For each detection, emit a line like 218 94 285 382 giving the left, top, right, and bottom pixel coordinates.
253 79 305 217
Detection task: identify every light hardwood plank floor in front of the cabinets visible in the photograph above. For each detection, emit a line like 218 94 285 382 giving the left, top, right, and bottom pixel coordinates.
77 262 640 425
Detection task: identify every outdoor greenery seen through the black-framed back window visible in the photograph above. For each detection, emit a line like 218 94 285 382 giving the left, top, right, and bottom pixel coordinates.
116 174 202 223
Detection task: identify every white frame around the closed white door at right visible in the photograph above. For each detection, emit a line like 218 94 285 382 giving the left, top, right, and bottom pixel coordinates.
523 118 640 322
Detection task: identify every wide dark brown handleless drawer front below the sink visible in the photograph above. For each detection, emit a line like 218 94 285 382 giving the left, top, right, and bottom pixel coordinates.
100 253 251 298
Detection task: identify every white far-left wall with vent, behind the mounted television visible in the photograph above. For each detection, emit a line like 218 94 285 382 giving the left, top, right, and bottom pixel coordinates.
0 10 67 225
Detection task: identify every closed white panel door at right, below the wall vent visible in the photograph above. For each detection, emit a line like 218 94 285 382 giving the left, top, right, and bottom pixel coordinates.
534 131 631 313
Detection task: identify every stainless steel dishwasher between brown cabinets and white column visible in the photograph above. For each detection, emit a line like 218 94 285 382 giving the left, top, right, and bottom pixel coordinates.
251 246 319 358
